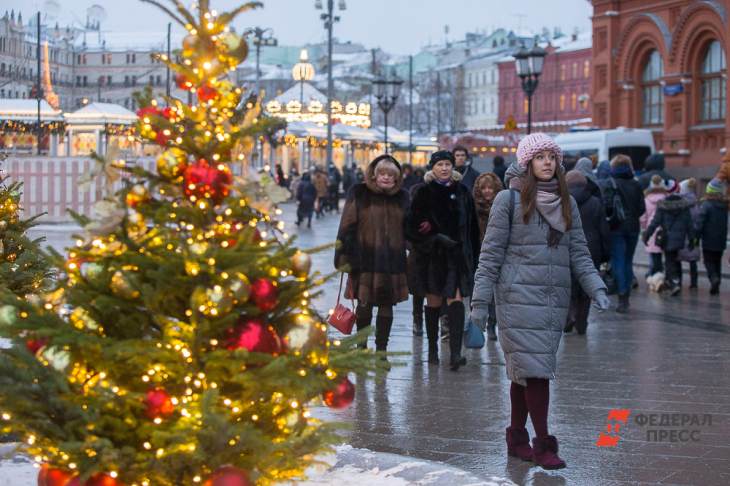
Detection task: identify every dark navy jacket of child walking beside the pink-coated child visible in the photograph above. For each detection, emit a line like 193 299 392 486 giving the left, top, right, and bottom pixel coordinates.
645 194 694 252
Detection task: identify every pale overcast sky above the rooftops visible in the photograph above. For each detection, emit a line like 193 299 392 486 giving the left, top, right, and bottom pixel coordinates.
5 0 592 54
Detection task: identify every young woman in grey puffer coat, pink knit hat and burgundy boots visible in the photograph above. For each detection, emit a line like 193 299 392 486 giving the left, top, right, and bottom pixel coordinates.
471 133 609 469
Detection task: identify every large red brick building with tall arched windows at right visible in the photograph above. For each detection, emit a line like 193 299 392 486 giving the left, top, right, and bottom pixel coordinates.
591 0 730 177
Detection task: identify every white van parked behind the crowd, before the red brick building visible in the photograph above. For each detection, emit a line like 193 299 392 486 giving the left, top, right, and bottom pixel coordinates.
555 127 654 171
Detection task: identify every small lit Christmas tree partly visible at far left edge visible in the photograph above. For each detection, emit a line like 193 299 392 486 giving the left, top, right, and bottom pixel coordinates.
0 173 52 297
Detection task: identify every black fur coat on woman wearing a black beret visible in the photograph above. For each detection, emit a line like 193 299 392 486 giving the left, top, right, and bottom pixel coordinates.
406 172 481 297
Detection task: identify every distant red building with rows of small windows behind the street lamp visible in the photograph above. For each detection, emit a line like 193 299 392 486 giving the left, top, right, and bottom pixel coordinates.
497 32 593 132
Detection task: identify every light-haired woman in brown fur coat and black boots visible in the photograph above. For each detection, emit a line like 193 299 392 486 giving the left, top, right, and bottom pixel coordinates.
335 155 409 352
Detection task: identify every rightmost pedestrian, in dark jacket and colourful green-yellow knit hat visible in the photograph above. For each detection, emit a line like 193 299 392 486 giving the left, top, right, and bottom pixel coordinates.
696 178 728 295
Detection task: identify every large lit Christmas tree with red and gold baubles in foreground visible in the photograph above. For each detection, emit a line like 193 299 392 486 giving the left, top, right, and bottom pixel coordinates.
0 0 382 486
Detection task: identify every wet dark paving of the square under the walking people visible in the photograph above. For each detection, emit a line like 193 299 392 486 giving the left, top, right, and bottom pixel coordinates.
28 205 730 486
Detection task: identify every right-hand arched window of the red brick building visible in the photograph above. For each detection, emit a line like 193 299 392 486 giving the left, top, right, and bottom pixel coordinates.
700 41 726 121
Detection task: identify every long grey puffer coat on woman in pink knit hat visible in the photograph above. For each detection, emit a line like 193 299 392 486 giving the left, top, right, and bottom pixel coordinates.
472 173 606 385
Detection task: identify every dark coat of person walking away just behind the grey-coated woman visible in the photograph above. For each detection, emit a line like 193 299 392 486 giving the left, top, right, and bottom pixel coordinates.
570 184 610 266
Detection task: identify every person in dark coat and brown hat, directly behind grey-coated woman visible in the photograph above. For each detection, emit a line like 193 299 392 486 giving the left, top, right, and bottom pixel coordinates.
564 170 611 335
